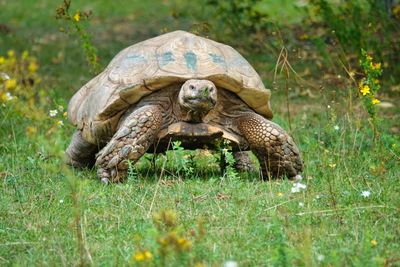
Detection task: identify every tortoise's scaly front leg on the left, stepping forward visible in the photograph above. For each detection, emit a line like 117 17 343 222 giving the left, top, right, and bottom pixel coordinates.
96 106 162 182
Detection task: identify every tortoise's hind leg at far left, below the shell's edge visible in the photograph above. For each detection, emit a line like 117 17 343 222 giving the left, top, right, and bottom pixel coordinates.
65 131 98 168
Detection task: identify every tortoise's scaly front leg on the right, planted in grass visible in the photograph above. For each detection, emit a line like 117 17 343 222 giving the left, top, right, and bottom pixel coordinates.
236 113 303 180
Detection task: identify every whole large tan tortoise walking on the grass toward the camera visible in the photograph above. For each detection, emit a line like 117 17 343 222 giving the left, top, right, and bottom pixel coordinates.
66 31 303 182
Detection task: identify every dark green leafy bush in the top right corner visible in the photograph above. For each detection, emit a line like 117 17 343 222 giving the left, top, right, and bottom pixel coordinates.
310 0 400 81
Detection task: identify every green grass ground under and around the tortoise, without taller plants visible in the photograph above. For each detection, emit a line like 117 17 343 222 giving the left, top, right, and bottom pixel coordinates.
0 1 400 266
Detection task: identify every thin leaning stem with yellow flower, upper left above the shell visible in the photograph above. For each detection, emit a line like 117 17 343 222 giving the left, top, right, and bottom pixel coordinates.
56 0 101 74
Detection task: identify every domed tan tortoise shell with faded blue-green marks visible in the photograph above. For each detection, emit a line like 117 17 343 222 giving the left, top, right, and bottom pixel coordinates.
68 31 272 144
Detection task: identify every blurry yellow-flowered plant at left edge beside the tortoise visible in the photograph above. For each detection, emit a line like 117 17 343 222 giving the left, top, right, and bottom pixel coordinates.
0 50 67 137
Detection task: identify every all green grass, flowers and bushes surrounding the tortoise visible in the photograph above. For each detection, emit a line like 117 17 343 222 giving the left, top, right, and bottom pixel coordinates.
0 0 400 266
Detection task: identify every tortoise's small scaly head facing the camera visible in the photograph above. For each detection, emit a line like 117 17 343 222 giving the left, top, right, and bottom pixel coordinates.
178 80 217 122
